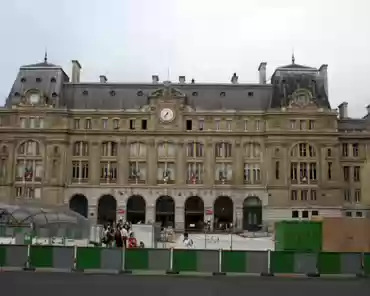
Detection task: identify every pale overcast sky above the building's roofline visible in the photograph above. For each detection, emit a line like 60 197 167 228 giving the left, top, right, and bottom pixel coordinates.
0 0 370 117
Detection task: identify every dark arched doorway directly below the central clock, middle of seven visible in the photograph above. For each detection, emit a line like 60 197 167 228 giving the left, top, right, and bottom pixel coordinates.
155 196 175 227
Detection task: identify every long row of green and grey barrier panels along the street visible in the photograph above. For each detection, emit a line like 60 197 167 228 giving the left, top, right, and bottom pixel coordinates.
0 245 370 276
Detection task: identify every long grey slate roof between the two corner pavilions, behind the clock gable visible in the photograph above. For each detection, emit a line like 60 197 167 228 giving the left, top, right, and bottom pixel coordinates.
62 83 271 110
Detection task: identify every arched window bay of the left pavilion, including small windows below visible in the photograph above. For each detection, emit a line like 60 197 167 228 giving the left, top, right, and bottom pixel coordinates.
15 140 44 199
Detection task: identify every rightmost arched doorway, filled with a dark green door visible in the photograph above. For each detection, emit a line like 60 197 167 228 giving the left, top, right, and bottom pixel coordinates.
243 196 262 231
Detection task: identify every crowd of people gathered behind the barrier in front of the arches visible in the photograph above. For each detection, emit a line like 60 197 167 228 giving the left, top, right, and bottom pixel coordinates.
102 219 144 248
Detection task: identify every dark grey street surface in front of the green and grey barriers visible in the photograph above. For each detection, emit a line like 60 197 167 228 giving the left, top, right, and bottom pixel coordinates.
0 272 370 296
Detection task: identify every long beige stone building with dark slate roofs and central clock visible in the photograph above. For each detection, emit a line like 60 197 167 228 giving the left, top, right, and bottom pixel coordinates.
0 56 370 229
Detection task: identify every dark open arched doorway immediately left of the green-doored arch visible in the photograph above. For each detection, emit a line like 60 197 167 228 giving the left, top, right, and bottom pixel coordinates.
213 196 234 230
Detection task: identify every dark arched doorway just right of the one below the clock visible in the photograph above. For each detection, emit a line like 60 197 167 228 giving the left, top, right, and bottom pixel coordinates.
185 196 204 231
